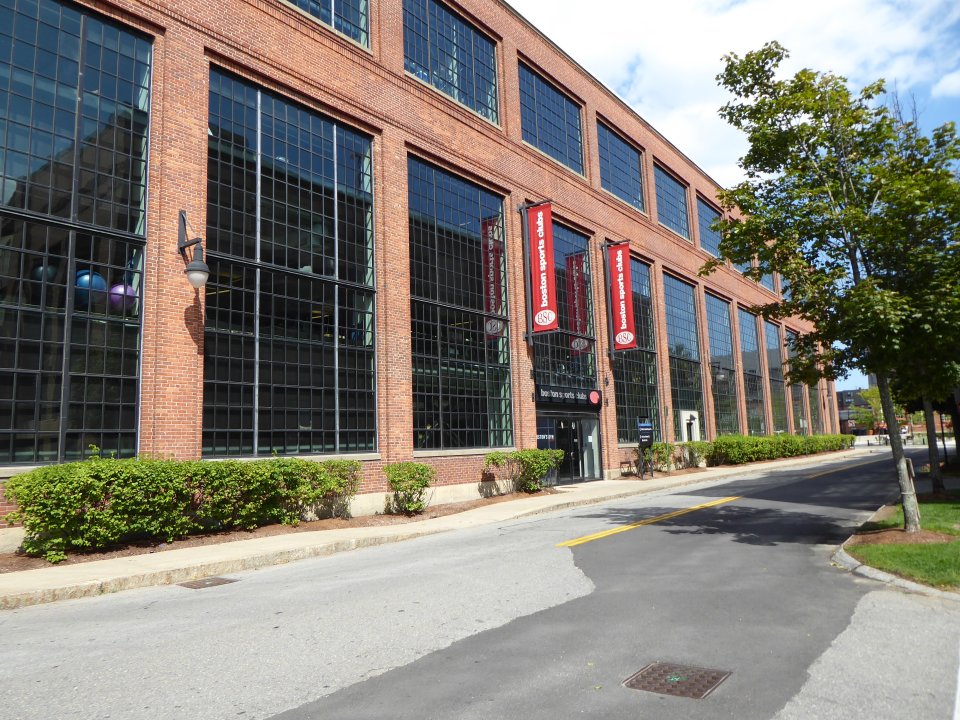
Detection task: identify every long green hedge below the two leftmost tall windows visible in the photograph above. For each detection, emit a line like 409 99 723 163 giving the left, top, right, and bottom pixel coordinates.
5 456 361 562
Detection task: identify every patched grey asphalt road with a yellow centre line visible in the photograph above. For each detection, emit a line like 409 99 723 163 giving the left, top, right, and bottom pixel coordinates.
0 450 960 720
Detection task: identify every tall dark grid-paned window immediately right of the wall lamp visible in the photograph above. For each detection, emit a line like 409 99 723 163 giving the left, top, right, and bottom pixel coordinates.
203 69 376 457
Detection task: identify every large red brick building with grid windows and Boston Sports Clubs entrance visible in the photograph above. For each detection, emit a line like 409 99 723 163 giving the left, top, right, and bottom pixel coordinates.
0 0 837 512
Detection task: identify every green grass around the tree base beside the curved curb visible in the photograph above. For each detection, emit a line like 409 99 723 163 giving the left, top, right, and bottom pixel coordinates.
846 492 960 589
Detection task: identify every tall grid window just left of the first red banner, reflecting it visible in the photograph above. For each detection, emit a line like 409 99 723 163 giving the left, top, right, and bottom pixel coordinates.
407 157 513 450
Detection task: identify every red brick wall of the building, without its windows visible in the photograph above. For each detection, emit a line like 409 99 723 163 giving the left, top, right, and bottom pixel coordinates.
39 0 824 498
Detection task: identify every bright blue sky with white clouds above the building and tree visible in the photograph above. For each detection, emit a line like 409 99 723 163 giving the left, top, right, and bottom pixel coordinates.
507 0 960 390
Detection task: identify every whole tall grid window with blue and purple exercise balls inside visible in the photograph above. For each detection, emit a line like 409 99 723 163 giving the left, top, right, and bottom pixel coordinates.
0 0 153 464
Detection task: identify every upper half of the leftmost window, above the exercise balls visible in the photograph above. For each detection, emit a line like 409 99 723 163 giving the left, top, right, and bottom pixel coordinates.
0 0 151 235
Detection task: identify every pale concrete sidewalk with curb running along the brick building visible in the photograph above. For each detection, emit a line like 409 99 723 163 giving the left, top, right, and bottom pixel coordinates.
0 447 904 609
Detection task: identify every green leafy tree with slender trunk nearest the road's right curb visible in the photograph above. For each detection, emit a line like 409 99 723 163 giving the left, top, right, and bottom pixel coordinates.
703 42 960 532
